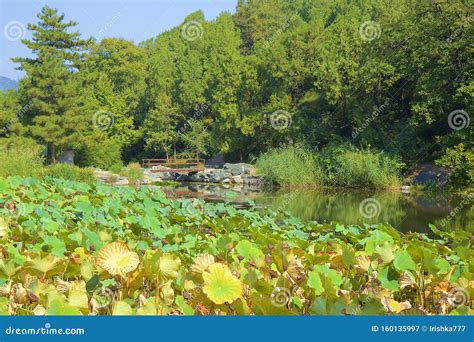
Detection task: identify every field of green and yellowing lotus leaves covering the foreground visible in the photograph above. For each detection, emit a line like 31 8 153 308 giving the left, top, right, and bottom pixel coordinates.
0 177 474 315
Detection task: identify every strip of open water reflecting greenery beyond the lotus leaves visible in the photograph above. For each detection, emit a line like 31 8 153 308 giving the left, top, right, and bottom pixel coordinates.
160 183 474 232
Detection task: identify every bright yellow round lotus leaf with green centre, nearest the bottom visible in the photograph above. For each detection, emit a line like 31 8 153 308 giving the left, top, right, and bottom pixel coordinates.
202 263 243 304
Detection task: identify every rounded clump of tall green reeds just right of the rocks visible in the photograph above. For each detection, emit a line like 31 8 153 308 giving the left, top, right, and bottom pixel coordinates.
256 144 324 187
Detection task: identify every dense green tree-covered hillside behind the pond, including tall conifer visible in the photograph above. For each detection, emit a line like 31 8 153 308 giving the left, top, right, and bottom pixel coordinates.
0 0 474 180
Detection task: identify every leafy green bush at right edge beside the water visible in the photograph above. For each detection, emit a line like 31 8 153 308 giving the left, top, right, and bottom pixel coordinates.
436 144 474 187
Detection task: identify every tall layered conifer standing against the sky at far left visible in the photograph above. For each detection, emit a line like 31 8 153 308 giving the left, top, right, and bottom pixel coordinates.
13 6 88 162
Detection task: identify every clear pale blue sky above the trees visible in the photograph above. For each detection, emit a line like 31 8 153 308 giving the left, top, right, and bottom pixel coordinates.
0 0 237 80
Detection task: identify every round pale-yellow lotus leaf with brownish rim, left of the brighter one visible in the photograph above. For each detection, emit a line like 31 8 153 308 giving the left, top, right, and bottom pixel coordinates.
96 242 140 276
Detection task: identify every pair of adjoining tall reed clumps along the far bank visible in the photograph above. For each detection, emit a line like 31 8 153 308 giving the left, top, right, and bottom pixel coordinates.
257 145 403 189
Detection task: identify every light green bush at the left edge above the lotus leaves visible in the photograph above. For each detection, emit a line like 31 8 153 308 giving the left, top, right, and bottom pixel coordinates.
0 139 44 177
